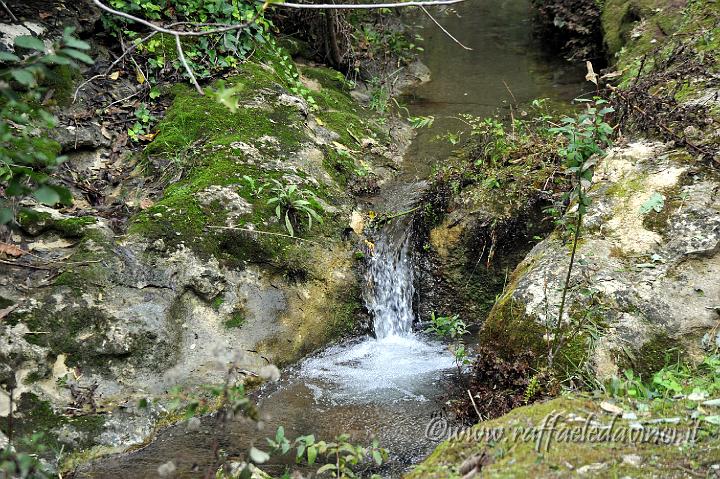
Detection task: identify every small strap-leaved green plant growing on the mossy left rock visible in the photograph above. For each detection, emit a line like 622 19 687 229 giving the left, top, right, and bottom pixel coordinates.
267 179 324 236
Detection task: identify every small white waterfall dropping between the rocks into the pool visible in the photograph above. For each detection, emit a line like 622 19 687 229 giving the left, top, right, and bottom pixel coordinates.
363 218 415 339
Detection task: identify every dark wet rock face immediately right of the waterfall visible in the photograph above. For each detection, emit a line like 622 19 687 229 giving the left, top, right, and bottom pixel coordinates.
416 178 550 326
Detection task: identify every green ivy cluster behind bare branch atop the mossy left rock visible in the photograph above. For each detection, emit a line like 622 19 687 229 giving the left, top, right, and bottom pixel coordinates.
103 0 271 83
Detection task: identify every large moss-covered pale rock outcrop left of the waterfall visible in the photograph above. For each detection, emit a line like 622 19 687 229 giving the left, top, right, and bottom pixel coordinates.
0 46 400 462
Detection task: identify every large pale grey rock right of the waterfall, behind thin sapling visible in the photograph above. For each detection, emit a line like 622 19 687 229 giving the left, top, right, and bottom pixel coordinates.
481 142 720 378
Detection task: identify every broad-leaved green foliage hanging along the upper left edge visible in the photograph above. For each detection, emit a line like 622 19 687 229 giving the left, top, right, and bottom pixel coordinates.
0 28 93 225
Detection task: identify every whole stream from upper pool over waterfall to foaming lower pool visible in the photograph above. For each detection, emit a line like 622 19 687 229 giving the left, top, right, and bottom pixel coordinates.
80 0 580 478
